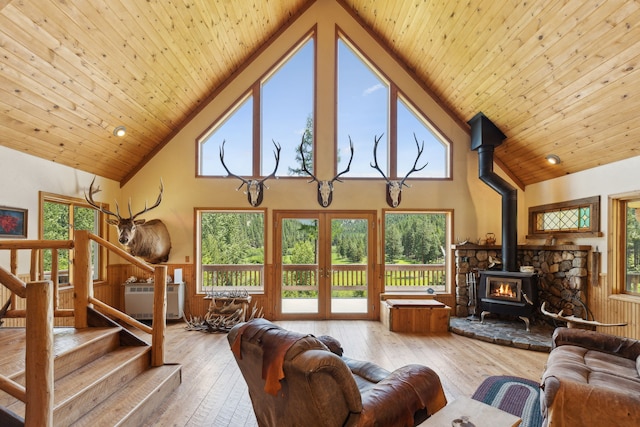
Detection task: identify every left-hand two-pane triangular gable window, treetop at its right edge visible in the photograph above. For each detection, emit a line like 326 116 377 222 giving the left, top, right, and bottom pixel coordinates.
198 35 315 177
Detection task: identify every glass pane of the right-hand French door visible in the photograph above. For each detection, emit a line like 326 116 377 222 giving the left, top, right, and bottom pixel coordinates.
328 219 369 313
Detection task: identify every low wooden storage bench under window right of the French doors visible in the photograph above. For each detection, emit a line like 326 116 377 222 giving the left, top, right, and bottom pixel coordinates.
380 299 451 332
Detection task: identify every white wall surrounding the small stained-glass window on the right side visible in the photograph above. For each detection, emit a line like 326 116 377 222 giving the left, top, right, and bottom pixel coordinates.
521 156 640 273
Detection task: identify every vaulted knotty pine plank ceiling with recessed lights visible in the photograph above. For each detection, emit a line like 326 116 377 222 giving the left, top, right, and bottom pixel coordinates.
0 0 640 185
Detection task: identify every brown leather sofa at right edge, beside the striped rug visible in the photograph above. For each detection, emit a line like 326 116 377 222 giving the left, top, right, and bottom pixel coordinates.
540 328 640 427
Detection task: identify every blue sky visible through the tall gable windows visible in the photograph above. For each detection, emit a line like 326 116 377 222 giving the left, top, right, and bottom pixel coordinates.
202 39 446 179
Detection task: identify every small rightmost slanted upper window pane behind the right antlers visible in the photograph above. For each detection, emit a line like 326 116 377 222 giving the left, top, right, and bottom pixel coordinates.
397 99 449 178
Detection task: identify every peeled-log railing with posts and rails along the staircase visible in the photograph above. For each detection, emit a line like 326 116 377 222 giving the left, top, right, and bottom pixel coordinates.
0 230 167 427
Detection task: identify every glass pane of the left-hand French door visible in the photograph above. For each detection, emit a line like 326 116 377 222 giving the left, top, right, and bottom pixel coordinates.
281 218 319 313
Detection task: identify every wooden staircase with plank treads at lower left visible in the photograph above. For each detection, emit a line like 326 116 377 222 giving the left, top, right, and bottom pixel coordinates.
0 308 181 427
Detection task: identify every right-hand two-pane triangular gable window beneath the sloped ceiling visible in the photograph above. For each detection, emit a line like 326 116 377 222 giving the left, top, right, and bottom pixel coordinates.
337 36 450 179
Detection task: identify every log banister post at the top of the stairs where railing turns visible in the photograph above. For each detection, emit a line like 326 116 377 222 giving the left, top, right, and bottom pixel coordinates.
73 230 93 329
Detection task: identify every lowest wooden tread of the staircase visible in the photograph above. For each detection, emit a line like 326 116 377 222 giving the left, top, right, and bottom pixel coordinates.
72 365 182 426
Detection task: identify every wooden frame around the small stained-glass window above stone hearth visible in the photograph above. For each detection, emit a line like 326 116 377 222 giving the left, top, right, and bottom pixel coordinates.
526 196 602 239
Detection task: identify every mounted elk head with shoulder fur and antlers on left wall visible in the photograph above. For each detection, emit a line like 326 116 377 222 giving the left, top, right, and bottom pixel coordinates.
84 177 171 264
